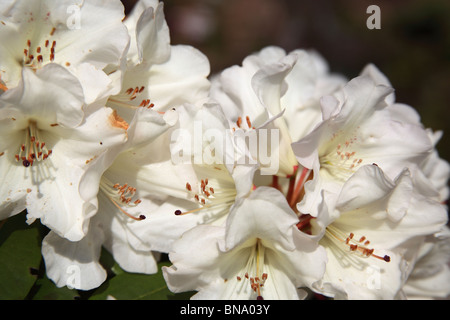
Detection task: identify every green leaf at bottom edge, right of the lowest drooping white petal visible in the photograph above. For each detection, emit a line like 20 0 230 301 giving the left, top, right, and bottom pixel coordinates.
90 262 193 300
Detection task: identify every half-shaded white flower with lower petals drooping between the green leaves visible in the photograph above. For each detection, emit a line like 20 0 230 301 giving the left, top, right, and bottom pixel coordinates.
42 109 173 290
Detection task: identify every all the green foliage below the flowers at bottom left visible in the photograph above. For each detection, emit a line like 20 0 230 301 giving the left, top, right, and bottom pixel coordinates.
0 212 194 300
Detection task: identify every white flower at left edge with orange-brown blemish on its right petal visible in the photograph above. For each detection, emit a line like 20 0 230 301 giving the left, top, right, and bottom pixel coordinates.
0 64 126 240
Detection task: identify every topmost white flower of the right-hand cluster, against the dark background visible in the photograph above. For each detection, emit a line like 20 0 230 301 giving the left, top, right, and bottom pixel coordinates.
211 47 344 177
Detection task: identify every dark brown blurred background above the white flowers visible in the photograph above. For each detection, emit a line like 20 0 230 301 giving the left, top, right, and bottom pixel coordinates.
123 0 450 178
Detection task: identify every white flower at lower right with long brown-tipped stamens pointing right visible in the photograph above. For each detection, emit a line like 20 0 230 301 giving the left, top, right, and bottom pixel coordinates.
305 165 447 299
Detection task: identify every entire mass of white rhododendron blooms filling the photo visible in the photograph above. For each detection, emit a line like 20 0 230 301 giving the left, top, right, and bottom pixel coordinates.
0 0 450 299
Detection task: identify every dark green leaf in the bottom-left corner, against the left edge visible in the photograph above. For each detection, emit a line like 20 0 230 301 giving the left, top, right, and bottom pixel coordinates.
0 212 42 300
